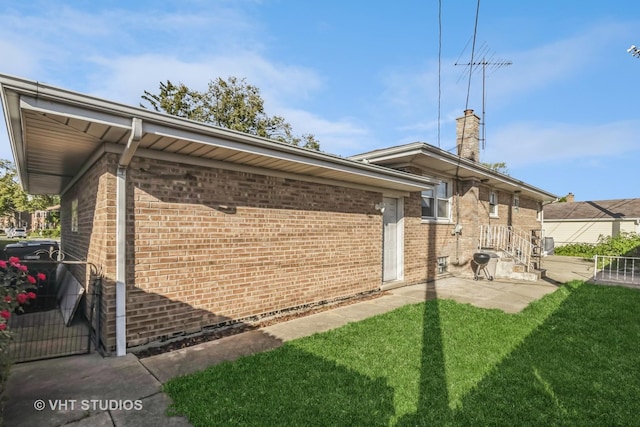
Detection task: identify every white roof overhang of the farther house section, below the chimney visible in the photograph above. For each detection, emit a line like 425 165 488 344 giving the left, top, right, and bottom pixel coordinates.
350 142 558 202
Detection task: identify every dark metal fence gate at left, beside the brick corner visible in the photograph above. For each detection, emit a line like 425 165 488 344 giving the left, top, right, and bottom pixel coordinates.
8 261 100 362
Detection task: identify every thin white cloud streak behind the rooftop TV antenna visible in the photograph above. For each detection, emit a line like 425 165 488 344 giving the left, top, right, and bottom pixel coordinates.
379 22 630 137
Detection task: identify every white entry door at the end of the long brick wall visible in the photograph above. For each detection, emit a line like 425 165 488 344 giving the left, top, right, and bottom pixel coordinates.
382 197 404 282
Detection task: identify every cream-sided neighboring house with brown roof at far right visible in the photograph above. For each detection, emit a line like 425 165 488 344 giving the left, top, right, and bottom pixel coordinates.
544 193 640 246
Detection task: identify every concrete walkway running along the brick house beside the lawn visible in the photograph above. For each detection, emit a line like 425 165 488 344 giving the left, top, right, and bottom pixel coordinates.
4 262 588 427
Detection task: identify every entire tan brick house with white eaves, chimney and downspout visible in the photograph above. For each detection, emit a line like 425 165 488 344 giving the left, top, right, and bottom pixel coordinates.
0 75 556 355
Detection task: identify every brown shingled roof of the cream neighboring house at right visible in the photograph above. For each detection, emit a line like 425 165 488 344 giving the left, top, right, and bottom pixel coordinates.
543 199 640 221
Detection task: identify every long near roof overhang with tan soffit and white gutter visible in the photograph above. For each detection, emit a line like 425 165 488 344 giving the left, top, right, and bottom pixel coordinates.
0 75 434 194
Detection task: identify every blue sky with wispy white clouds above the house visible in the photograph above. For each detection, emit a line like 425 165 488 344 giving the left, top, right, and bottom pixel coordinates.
0 0 640 201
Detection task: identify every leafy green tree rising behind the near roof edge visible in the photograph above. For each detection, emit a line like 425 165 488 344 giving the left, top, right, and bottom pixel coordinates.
140 77 320 150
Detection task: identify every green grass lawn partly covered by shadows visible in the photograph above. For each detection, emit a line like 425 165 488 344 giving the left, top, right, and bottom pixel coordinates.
165 282 640 426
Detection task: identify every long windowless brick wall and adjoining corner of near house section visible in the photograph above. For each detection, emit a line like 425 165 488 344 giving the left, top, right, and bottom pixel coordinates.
62 155 382 350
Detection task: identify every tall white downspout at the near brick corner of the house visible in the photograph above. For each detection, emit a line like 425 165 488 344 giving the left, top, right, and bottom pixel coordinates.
116 117 142 356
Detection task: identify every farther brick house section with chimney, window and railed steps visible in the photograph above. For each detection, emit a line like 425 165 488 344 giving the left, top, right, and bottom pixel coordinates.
351 110 557 283
